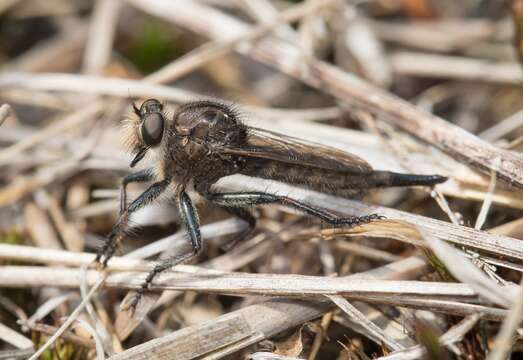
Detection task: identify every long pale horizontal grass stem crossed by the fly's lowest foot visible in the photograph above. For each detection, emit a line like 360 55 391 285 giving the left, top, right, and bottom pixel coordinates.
0 266 492 300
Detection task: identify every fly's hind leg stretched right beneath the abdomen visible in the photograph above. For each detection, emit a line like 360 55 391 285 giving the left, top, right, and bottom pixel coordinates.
209 192 383 227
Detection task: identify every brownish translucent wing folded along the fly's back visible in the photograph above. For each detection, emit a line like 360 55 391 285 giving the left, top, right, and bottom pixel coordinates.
221 127 372 174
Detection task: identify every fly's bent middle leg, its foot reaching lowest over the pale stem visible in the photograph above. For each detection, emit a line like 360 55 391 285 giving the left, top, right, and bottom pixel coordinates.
129 190 202 310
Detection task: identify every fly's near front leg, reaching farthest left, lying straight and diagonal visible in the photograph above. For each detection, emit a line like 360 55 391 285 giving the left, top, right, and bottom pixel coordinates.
95 178 171 267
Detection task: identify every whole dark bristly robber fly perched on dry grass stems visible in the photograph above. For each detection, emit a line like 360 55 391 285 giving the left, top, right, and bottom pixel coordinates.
96 99 446 308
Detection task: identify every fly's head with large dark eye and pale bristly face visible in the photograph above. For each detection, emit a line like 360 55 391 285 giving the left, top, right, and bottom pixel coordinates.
126 99 166 167
